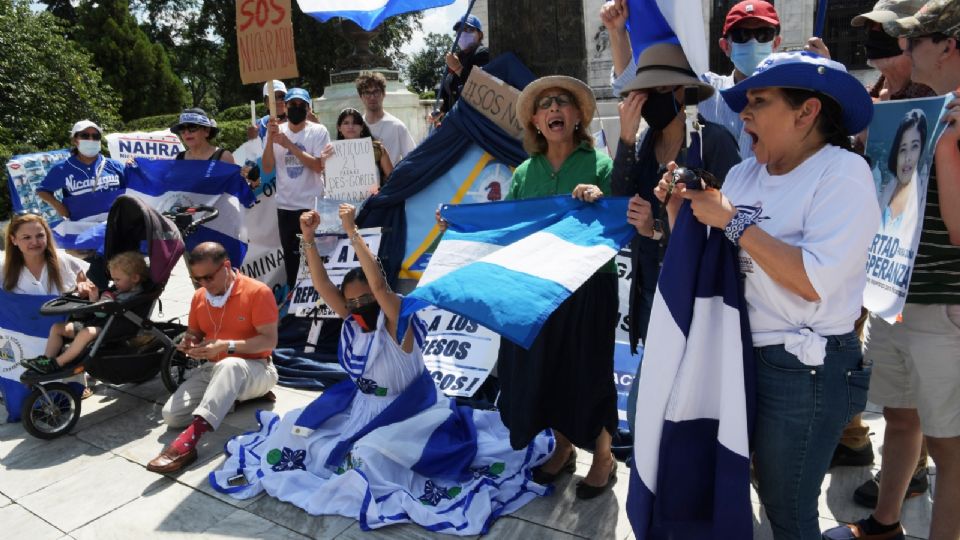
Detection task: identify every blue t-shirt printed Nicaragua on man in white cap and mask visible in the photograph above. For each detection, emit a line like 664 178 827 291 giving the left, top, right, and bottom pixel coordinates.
37 155 127 221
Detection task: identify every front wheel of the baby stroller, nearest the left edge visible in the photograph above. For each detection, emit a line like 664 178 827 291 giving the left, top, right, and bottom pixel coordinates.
20 383 80 439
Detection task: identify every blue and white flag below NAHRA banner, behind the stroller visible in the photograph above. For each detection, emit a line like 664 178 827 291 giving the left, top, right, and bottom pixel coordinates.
126 158 257 268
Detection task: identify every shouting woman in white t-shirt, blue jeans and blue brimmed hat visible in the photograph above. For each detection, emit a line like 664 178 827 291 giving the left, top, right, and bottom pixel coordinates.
656 52 880 540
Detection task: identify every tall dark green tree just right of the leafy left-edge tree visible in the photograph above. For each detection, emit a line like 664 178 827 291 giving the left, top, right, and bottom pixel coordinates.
75 0 187 119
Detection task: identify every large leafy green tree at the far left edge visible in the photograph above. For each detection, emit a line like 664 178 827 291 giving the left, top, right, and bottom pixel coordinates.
0 0 119 219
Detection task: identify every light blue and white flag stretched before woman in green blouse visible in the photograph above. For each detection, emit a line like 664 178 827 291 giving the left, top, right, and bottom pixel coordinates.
398 195 636 348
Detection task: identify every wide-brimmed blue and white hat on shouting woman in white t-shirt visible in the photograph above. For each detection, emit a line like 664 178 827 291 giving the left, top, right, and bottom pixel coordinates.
720 51 873 135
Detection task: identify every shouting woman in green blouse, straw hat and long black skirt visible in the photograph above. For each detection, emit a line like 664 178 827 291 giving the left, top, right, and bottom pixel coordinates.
498 76 619 499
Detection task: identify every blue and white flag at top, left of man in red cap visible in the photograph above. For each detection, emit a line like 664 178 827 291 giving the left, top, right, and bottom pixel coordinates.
627 0 710 75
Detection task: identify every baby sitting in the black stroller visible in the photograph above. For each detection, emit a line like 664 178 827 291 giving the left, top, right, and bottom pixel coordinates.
20 251 149 374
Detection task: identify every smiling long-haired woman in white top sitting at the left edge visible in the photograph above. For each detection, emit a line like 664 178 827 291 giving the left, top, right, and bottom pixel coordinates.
0 214 96 297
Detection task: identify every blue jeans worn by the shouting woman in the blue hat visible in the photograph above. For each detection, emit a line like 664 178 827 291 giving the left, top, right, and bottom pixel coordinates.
753 332 870 540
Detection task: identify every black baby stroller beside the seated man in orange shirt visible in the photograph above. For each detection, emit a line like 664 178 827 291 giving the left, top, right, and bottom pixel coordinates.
20 195 217 439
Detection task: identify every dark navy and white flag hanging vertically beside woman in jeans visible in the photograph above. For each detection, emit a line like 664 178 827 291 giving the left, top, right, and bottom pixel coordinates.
627 203 754 540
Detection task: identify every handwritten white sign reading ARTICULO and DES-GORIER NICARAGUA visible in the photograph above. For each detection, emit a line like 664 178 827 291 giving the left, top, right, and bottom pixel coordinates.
323 137 380 202
